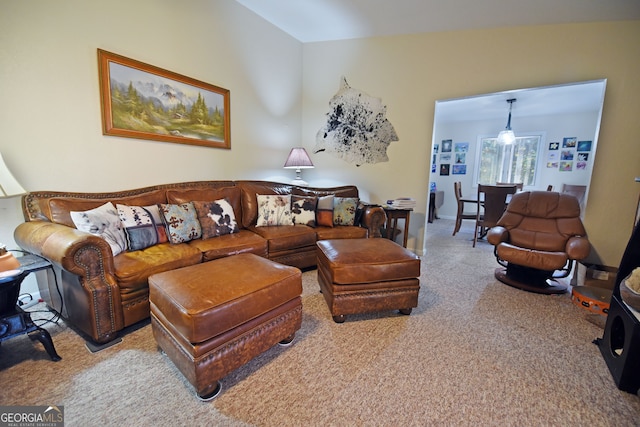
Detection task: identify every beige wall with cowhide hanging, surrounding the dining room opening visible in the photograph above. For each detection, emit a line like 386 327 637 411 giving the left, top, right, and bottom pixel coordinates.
302 21 640 266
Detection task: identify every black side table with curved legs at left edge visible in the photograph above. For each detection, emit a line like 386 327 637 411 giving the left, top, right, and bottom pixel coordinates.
0 254 62 362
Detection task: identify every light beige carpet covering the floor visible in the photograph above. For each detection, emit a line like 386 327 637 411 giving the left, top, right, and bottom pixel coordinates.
0 219 640 426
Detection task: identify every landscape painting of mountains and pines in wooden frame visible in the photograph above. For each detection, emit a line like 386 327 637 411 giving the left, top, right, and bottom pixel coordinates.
98 49 231 149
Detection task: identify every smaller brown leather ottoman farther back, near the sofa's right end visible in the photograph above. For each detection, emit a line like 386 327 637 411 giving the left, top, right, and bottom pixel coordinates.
316 238 420 323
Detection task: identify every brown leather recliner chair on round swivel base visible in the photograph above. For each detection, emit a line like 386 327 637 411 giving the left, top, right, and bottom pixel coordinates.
487 191 591 294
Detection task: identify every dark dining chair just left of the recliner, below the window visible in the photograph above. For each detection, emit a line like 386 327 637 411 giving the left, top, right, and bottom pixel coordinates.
473 184 518 248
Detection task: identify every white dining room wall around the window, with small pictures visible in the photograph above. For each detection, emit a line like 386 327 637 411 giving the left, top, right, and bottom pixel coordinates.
429 112 598 218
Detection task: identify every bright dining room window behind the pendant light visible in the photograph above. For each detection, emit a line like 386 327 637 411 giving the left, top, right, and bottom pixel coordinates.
476 135 542 186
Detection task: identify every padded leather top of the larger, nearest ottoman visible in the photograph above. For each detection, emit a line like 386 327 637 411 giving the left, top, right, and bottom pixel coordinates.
149 253 302 343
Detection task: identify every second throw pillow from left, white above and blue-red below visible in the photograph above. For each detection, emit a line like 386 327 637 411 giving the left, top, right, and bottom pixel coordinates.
116 204 167 251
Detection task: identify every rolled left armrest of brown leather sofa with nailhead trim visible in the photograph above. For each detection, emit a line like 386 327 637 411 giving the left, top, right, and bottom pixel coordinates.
14 221 124 342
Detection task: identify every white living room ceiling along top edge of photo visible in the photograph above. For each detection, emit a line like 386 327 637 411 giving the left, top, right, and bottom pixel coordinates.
236 0 640 43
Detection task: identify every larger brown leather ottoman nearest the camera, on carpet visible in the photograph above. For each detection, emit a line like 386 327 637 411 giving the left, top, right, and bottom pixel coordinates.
149 253 302 400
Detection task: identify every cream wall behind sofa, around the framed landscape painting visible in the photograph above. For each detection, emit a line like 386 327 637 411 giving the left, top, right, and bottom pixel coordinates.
0 0 302 296
